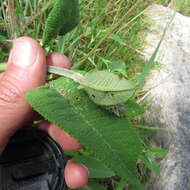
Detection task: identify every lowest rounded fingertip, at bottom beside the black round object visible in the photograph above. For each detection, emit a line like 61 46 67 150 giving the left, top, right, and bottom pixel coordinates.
65 161 89 189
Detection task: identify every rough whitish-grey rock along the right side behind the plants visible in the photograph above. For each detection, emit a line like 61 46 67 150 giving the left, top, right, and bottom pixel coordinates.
144 5 190 190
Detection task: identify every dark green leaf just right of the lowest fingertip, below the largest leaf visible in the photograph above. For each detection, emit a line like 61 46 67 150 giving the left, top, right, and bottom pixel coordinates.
72 155 115 178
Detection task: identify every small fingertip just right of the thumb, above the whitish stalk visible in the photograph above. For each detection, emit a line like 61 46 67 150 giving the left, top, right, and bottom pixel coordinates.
47 52 71 69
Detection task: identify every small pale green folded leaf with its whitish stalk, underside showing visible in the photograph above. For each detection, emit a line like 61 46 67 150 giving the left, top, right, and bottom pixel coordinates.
48 66 135 96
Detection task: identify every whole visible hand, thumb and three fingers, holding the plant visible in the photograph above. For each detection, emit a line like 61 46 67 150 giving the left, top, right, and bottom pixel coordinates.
0 37 89 189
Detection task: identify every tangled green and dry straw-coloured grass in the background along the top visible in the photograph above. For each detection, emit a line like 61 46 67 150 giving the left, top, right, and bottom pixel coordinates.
0 0 190 73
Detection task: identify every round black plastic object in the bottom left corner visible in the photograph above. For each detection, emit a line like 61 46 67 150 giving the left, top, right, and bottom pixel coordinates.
0 127 66 190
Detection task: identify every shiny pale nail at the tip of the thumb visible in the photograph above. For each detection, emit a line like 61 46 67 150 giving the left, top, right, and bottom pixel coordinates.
8 38 38 68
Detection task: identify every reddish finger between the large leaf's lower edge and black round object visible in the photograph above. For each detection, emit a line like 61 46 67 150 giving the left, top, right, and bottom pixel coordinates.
39 122 82 151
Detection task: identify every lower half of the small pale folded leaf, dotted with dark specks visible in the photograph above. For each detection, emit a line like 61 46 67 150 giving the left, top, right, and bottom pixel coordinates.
84 88 135 106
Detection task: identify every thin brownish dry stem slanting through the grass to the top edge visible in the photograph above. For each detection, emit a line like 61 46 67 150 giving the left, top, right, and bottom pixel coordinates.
72 0 141 69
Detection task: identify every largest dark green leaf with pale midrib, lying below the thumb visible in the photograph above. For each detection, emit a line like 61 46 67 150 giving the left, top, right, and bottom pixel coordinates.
26 78 143 190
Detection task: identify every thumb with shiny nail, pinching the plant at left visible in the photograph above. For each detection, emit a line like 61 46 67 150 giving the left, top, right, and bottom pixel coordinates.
0 37 46 151
